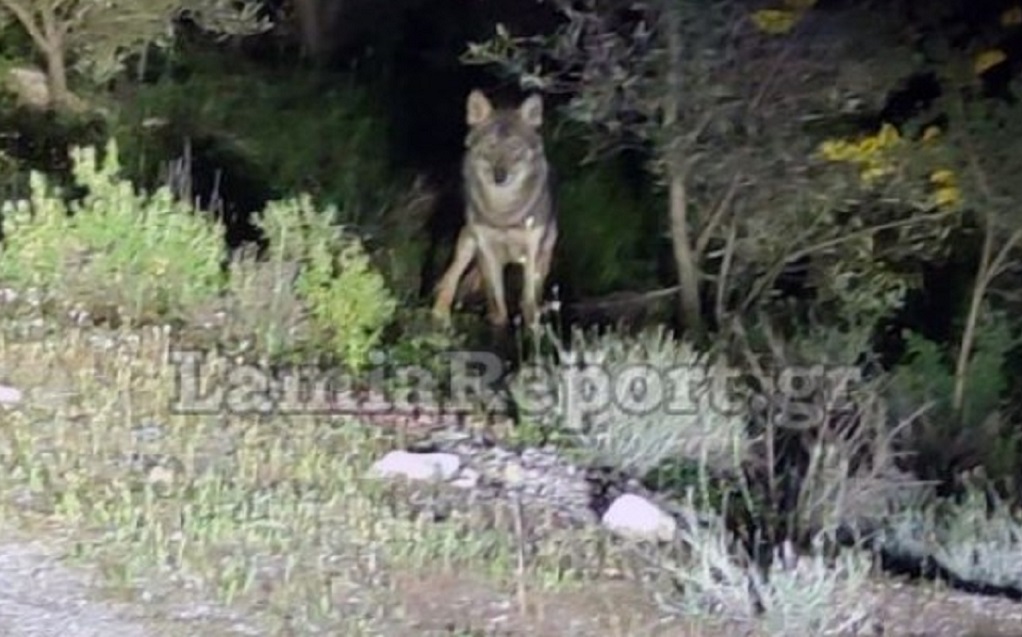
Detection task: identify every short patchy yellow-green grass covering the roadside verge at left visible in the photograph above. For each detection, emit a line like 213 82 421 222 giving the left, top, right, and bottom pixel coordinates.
0 321 649 634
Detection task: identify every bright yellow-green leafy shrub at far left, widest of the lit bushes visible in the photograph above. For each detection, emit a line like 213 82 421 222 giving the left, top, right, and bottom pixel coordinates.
0 141 224 320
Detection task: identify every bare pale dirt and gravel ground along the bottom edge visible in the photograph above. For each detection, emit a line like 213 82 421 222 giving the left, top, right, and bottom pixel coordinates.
0 532 1022 637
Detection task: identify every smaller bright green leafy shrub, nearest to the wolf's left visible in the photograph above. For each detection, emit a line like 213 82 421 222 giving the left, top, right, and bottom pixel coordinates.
247 195 398 369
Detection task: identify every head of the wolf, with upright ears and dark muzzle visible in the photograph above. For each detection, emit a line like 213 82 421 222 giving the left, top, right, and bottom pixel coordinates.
465 90 546 190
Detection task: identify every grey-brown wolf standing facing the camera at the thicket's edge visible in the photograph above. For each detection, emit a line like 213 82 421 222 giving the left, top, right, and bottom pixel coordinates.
433 89 558 328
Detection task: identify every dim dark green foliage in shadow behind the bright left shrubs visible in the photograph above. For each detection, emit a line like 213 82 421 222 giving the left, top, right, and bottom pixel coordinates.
114 51 434 304
